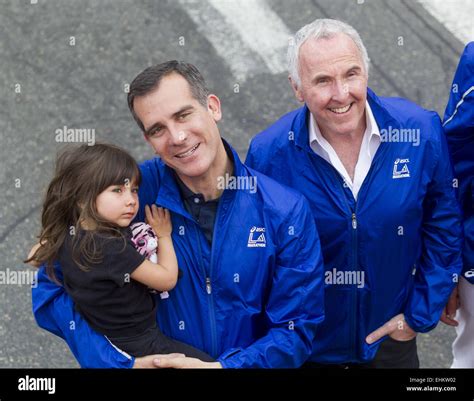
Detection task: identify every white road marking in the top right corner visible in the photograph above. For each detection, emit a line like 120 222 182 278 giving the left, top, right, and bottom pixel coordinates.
418 0 474 43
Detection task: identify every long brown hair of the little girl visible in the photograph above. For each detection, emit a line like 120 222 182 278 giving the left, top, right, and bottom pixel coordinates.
25 143 141 283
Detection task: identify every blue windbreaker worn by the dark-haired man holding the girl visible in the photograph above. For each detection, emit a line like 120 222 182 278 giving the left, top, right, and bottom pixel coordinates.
32 142 324 368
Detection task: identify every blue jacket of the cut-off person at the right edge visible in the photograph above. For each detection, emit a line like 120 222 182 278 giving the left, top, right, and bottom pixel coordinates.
443 42 474 284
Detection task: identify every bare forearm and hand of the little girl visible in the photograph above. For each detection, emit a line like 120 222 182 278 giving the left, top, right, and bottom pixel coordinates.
131 205 178 291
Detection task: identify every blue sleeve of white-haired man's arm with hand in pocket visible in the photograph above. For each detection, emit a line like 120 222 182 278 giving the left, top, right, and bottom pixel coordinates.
405 116 462 333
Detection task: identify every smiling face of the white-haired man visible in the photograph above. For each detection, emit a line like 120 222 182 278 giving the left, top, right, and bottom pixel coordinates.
292 34 367 136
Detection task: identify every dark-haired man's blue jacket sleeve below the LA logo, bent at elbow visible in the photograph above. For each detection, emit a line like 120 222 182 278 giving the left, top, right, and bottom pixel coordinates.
218 197 324 368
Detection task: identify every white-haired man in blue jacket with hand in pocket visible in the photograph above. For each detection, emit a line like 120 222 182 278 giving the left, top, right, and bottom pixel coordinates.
246 19 462 368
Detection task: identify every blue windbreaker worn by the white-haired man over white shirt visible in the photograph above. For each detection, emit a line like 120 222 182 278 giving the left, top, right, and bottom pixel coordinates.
246 89 462 363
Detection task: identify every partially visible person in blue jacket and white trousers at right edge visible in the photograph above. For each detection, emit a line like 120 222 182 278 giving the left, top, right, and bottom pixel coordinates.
441 42 474 368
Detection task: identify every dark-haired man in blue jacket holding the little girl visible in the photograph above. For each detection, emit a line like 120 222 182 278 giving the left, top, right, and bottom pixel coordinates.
33 61 324 368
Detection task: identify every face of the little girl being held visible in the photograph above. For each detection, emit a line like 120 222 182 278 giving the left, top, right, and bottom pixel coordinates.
96 180 138 227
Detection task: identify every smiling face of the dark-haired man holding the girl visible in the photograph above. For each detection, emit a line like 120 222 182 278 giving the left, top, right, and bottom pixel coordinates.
133 73 222 177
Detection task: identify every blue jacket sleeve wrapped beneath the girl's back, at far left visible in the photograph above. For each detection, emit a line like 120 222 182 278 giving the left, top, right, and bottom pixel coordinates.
32 265 135 368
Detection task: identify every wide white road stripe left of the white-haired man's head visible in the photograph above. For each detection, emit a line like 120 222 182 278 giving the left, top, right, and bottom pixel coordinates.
179 0 292 81
